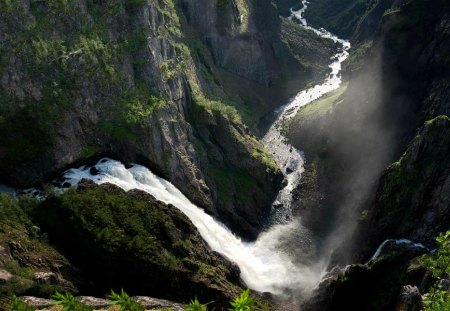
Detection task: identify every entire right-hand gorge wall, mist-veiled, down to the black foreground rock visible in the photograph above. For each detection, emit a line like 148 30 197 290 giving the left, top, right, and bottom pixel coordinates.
289 0 450 310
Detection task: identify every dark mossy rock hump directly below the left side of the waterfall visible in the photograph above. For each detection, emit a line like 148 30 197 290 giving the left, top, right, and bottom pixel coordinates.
34 181 246 307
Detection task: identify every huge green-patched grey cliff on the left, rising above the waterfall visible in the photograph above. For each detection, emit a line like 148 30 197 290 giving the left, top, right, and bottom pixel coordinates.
0 0 294 237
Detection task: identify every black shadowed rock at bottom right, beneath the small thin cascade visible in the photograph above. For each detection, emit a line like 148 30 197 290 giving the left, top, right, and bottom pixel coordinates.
301 247 423 311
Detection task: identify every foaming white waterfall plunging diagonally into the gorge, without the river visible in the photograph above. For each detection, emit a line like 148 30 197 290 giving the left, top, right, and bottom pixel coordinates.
64 158 320 295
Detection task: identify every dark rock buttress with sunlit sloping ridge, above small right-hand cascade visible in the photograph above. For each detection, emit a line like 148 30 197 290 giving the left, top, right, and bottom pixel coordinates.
361 116 450 256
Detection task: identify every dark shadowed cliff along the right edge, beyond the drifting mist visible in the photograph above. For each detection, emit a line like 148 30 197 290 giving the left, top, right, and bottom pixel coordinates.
354 1 450 256
